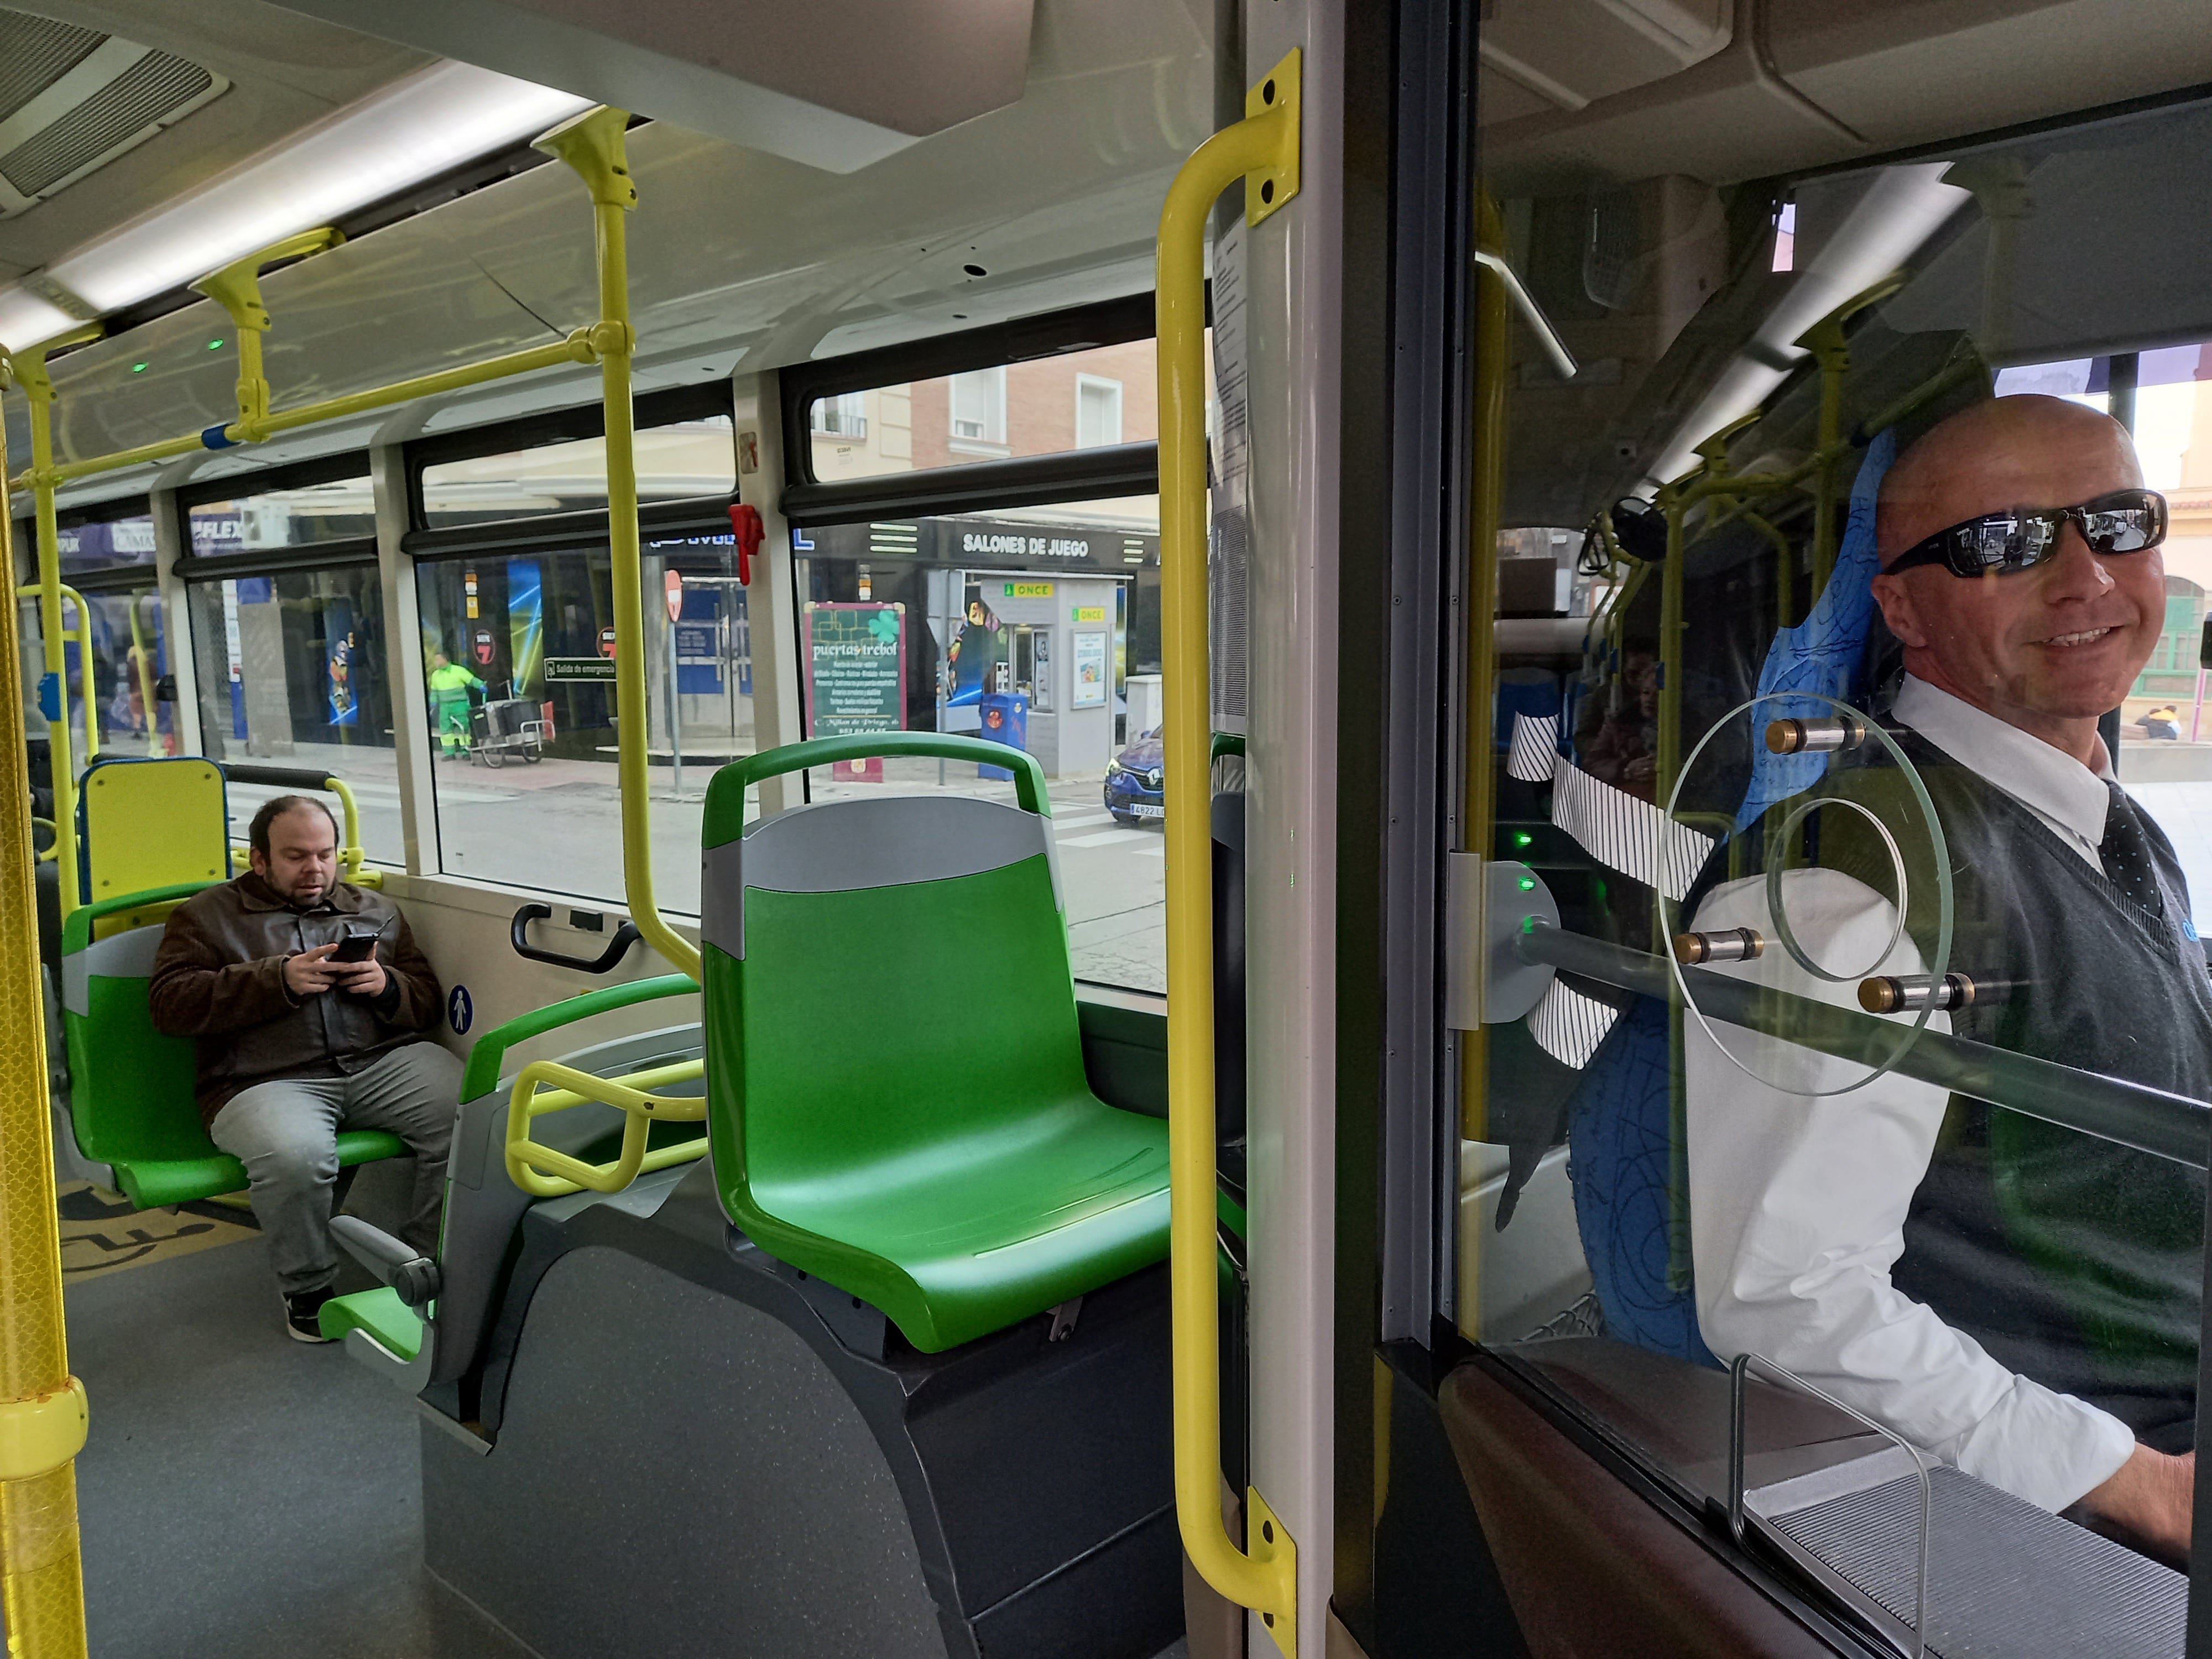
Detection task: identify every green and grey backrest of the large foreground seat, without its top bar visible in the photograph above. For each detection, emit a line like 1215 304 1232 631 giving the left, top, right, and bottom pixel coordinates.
706 796 1091 1194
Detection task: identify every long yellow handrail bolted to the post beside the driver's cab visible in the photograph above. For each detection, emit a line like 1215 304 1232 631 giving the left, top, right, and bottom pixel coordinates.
1157 51 1298 1655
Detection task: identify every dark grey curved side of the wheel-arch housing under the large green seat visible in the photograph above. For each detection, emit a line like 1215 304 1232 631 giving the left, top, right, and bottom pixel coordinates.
422 1245 945 1659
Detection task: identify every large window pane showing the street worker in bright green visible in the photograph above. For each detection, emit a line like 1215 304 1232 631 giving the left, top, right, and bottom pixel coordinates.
416 535 754 914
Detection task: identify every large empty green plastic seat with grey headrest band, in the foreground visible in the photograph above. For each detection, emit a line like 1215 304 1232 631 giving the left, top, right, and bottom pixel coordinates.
701 732 1168 1352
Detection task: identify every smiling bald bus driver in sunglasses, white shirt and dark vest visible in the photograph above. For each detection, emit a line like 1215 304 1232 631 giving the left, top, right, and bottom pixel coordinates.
1686 396 2212 1559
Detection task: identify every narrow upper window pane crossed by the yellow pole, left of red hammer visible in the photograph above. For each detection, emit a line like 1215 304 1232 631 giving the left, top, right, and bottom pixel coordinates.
422 414 737 529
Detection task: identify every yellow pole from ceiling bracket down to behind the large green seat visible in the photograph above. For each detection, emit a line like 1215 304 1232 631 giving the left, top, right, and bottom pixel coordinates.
538 104 699 980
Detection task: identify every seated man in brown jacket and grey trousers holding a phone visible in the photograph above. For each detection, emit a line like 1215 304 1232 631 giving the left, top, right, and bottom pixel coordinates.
148 794 460 1343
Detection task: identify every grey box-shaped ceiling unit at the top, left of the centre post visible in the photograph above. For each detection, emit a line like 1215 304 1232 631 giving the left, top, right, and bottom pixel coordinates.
263 0 1035 173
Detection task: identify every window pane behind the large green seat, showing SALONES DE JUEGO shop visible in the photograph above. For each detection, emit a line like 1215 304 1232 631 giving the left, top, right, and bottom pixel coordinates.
792 498 1166 991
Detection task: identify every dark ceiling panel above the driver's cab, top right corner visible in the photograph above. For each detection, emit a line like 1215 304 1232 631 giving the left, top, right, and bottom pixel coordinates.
1482 0 2212 197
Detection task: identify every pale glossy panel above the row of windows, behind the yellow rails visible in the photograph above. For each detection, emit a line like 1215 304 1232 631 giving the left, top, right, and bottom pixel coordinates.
18 0 1212 460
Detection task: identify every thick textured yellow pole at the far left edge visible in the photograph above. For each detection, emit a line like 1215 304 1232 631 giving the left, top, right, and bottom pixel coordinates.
0 365 86 1659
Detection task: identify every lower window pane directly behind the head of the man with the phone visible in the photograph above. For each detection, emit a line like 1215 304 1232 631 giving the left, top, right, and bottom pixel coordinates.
186 564 407 865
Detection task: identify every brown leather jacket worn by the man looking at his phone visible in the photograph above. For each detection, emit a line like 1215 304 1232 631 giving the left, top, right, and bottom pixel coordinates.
146 874 445 1124
